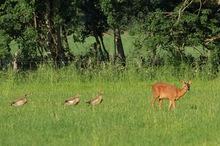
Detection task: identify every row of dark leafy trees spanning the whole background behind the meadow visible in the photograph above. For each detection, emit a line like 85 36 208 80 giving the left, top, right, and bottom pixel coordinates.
0 0 220 71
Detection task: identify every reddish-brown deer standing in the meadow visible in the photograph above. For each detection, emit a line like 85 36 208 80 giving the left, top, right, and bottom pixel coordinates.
152 81 192 109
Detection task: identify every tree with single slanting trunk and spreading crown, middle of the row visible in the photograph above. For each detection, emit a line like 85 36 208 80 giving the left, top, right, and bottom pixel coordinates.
100 0 147 66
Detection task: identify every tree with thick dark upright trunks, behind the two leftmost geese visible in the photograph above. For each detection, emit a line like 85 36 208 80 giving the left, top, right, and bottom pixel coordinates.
35 0 76 67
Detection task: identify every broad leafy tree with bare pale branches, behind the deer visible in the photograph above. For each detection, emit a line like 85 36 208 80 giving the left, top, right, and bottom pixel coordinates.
132 0 220 73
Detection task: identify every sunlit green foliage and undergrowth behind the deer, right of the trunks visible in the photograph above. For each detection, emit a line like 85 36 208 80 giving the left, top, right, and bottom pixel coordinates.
132 1 220 75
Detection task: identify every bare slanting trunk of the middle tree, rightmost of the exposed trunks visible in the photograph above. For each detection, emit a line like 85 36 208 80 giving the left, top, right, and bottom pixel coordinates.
114 27 126 66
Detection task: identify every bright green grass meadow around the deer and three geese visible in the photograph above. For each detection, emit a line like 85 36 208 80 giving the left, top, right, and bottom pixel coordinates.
0 67 220 146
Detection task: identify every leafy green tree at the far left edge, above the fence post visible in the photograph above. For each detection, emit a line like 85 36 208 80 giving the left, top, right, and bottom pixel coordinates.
0 0 37 67
